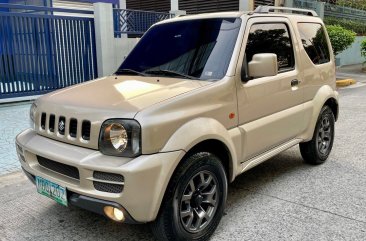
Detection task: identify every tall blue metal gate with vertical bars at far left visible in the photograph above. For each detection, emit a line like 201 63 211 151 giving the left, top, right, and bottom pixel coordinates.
0 4 97 99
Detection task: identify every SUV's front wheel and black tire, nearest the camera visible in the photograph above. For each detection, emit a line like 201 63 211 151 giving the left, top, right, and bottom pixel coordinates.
151 152 228 240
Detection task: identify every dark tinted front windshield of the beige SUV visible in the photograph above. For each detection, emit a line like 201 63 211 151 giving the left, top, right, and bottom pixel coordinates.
116 18 241 80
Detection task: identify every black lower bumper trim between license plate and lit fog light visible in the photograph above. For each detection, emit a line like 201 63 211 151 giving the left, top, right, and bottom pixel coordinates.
67 190 140 224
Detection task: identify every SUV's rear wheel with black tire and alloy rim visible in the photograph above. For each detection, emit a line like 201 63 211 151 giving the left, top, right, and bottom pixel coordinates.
300 106 335 165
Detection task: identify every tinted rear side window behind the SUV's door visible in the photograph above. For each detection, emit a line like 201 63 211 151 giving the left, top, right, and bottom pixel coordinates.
298 23 330 64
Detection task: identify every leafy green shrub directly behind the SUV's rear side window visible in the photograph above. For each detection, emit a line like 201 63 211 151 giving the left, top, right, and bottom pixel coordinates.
326 25 356 55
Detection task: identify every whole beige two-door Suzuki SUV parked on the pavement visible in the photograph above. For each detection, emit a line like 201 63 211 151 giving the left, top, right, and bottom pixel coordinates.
16 7 338 240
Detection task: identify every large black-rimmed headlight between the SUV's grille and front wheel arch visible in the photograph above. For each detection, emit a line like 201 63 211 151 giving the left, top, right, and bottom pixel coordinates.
99 119 141 157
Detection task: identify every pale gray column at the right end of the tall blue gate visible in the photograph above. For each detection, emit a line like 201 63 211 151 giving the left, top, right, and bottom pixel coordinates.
94 3 115 77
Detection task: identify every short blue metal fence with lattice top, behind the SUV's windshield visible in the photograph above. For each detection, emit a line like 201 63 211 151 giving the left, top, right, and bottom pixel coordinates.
113 9 173 38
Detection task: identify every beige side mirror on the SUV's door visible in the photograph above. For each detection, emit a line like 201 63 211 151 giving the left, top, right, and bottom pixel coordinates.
248 54 278 78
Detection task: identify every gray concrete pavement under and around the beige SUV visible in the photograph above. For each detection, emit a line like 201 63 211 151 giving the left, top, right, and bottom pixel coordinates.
0 86 366 241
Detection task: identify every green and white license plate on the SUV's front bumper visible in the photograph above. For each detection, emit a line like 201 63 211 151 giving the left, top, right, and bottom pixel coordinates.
36 176 67 206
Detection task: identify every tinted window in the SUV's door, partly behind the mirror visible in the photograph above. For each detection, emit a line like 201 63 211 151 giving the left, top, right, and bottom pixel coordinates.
245 23 295 72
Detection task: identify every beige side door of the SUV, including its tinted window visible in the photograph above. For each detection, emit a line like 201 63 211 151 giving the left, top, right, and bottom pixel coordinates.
237 17 305 161
